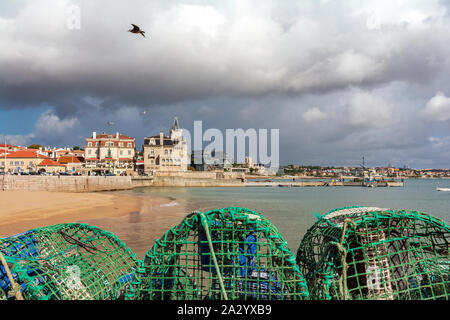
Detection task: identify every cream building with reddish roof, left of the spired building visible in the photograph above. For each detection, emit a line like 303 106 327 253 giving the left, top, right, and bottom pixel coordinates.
84 132 136 175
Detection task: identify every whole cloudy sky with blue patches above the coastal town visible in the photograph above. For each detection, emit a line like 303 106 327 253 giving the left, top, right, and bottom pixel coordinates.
0 0 450 168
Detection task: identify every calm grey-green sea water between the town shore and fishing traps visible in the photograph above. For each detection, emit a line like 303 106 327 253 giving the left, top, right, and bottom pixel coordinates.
118 179 450 253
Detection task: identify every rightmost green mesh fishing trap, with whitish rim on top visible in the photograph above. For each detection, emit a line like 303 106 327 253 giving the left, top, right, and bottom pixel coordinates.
297 207 450 300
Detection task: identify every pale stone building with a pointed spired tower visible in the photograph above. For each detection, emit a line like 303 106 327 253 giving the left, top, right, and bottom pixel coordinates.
143 117 189 174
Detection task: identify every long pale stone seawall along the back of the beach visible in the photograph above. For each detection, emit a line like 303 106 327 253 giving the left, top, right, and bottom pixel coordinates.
0 175 133 192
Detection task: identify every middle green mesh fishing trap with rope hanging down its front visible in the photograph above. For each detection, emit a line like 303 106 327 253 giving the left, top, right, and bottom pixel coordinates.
127 208 308 300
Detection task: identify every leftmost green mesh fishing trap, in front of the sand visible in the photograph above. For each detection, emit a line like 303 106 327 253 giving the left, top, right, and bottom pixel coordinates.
0 224 138 300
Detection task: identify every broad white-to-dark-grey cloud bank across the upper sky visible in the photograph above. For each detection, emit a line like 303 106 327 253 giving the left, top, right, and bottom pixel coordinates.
0 1 448 107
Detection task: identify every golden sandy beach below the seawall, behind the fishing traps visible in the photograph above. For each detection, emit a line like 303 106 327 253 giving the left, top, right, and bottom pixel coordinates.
0 191 191 257
